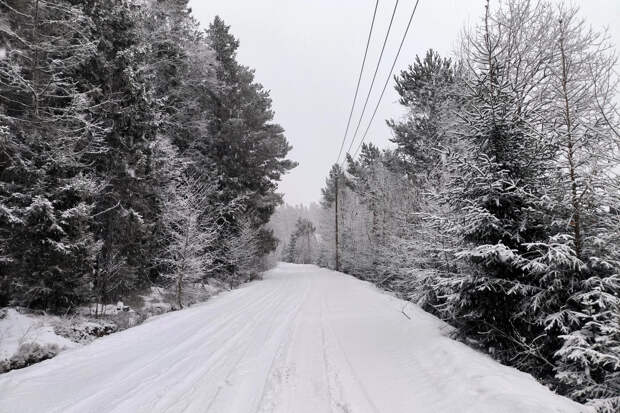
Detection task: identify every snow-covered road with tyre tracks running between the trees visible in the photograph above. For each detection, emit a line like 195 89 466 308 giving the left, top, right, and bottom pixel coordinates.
0 264 585 413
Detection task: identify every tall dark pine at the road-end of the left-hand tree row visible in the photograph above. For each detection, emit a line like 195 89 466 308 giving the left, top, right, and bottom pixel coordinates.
207 17 295 255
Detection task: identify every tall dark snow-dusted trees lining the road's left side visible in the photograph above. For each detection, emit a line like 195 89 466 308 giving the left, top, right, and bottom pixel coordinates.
0 0 295 312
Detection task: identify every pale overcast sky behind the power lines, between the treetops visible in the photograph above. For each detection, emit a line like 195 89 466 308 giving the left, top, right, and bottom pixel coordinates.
190 0 620 204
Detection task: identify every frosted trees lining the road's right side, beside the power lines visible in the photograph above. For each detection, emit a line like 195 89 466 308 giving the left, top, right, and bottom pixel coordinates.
284 1 620 412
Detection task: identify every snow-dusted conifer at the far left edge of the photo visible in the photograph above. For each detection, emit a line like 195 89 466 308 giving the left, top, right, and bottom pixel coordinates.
0 1 106 310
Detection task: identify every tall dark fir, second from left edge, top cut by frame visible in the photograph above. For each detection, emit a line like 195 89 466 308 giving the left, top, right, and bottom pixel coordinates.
80 0 168 301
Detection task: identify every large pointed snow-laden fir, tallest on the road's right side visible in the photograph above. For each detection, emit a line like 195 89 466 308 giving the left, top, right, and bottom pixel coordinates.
439 3 554 375
